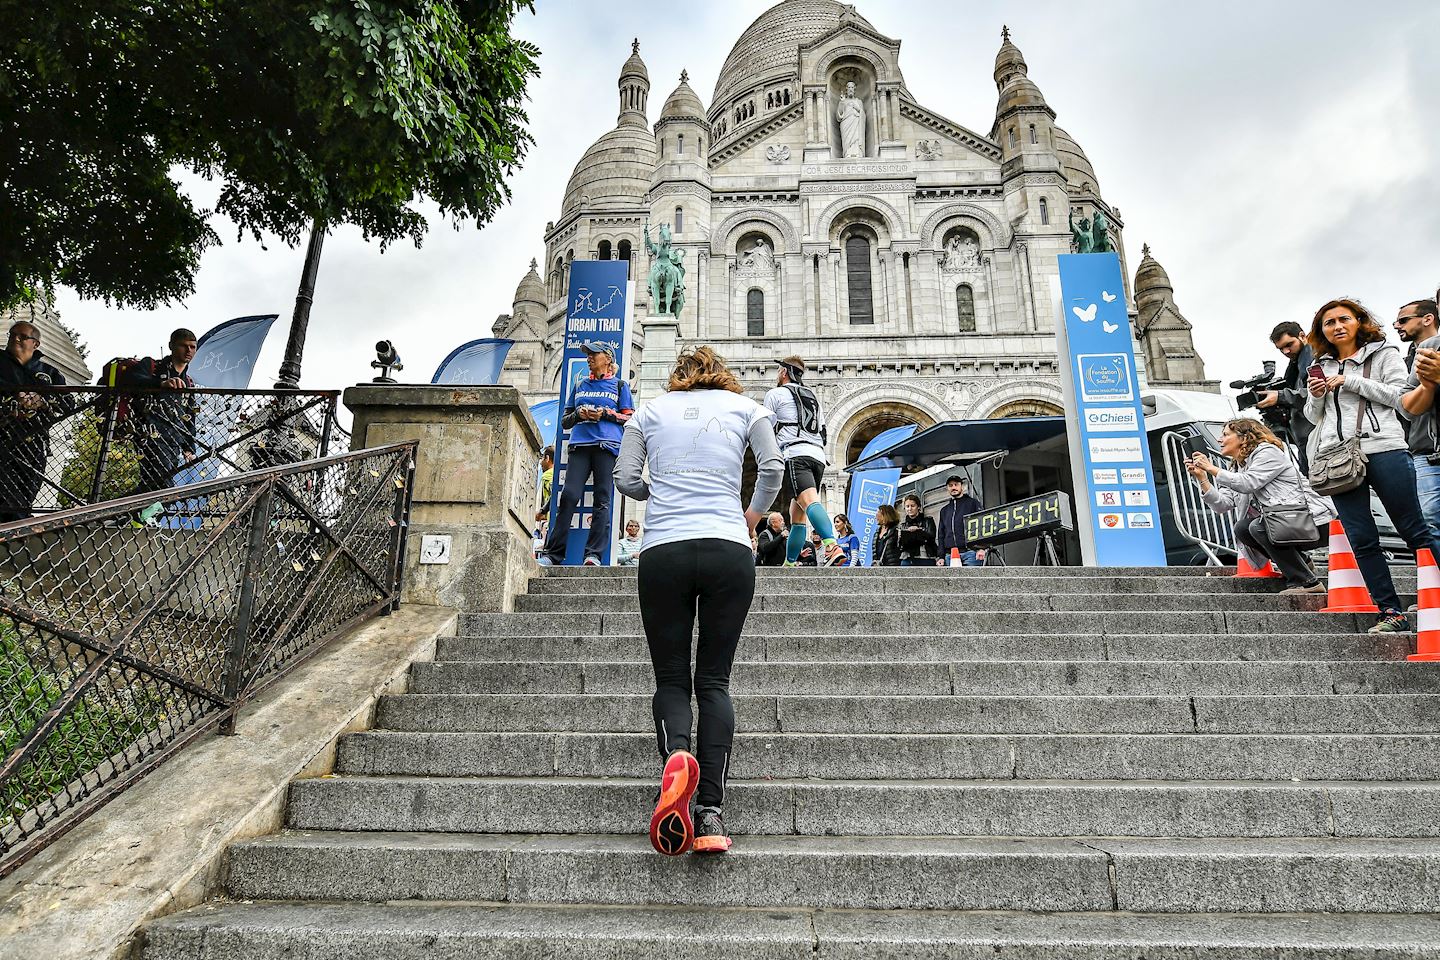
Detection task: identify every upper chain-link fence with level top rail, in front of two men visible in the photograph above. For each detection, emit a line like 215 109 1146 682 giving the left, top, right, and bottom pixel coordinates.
0 387 350 522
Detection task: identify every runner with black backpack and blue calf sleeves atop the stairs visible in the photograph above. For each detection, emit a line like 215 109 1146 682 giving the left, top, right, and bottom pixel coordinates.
765 357 845 567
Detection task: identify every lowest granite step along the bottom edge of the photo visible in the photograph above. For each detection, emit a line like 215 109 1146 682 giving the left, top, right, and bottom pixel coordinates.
144 901 1440 960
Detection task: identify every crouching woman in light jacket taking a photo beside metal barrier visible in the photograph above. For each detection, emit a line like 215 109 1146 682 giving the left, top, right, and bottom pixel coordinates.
1185 417 1335 593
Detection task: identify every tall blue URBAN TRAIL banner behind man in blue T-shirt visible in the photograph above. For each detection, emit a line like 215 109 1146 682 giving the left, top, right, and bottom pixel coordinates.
550 261 631 564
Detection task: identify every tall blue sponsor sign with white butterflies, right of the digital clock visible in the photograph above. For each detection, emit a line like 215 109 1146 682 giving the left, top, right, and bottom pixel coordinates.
1056 253 1165 567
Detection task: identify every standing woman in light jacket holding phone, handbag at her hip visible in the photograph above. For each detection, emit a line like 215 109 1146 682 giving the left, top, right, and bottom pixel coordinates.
1305 298 1436 633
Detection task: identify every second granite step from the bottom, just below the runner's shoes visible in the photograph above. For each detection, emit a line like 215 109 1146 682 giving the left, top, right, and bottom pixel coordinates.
226 830 1440 914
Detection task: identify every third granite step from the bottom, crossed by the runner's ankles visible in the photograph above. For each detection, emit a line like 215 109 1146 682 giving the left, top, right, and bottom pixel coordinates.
287 776 1440 838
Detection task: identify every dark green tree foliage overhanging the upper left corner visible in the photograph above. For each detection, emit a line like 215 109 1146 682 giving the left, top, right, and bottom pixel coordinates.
0 0 539 307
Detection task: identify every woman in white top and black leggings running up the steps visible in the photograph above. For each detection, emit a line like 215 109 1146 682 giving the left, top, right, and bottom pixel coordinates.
615 347 785 856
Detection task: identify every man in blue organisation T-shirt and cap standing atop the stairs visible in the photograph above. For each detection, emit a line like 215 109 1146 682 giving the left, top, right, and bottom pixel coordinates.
537 341 635 567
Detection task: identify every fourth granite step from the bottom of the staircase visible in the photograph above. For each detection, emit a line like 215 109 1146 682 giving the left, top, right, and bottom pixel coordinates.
336 730 1440 780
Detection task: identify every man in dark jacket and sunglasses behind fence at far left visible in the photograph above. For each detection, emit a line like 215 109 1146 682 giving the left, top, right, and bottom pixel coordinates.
0 321 71 524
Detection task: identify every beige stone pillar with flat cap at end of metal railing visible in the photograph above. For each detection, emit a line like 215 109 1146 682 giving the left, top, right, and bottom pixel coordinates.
344 384 543 613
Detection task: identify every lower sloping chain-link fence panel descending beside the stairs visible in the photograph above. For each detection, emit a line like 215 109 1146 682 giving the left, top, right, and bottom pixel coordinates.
0 443 415 875
